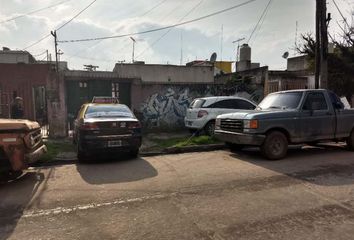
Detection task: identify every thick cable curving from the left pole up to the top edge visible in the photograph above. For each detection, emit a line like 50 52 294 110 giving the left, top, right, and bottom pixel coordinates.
58 0 257 43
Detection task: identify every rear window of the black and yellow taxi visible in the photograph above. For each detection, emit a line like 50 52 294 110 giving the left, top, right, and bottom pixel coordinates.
85 105 134 118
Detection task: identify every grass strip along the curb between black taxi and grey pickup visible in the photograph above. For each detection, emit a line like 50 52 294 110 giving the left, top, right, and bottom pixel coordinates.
154 136 220 148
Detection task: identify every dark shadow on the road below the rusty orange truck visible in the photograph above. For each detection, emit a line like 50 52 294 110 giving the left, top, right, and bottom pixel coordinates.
0 172 44 240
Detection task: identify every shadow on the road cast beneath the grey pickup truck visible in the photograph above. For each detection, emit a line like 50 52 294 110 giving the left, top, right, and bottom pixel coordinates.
231 145 354 186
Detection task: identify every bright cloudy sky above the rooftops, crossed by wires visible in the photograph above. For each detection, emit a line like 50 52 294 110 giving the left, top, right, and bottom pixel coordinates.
0 0 354 71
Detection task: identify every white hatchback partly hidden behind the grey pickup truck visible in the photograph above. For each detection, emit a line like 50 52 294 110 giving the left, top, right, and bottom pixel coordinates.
184 96 257 136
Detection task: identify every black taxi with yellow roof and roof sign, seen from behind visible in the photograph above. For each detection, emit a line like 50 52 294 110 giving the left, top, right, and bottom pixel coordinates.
73 97 142 161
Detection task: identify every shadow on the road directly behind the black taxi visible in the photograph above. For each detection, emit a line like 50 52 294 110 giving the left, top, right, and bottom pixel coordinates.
76 156 158 184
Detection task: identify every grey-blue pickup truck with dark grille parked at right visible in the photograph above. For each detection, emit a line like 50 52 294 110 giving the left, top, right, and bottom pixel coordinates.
215 89 354 160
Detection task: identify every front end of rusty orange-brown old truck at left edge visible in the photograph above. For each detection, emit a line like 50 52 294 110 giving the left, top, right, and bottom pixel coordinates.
0 119 47 179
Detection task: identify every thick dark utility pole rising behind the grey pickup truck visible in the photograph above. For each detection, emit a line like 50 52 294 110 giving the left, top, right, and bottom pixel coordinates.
315 0 330 89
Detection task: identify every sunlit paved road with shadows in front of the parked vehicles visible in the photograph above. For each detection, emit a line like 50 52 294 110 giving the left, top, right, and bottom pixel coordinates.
0 145 354 240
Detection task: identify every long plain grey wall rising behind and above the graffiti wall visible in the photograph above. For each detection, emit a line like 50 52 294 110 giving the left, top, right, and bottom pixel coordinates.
113 64 214 83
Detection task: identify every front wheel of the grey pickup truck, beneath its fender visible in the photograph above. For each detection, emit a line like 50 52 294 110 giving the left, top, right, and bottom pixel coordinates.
261 131 288 160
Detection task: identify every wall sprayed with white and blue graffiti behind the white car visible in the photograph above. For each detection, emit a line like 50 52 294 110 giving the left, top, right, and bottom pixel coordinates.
137 84 263 130
